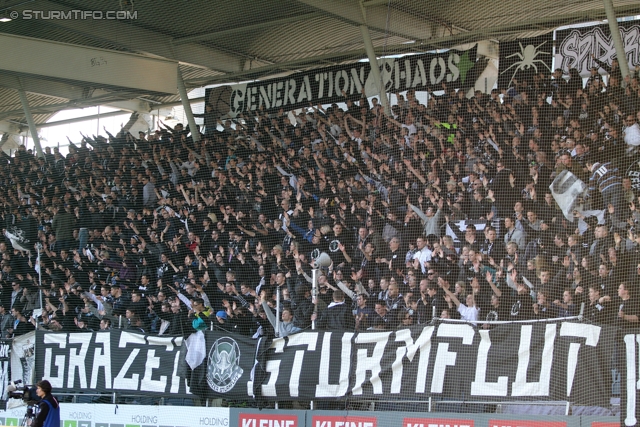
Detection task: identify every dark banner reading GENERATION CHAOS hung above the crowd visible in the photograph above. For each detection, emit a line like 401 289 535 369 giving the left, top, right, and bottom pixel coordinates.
205 46 478 117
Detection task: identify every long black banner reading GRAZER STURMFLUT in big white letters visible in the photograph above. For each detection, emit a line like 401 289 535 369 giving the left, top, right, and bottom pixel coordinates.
36 322 616 406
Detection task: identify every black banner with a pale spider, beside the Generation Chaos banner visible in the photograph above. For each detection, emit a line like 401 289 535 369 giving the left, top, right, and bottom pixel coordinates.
498 32 553 88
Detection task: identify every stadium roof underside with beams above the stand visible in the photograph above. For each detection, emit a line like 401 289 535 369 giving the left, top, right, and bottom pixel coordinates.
0 0 640 133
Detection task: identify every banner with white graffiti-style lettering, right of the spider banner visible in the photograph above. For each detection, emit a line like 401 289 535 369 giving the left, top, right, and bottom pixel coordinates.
556 20 640 77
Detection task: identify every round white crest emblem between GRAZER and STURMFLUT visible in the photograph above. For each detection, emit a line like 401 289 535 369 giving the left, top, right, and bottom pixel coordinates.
207 337 244 393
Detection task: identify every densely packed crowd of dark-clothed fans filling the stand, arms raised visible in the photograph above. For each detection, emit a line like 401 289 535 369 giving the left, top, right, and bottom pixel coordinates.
0 64 640 337
